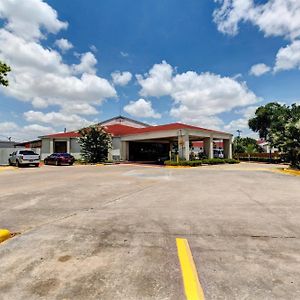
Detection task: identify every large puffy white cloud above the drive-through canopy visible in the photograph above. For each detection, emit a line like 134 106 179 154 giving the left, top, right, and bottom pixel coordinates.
137 61 259 128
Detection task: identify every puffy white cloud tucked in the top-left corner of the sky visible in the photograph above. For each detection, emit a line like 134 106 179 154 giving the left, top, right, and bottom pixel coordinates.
0 0 68 40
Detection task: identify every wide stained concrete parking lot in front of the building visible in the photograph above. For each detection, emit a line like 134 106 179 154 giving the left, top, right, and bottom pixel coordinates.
0 163 300 300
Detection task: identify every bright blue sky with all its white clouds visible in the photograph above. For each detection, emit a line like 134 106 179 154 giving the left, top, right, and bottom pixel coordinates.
0 0 300 140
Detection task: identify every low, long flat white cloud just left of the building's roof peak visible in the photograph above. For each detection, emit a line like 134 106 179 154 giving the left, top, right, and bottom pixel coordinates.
24 110 91 130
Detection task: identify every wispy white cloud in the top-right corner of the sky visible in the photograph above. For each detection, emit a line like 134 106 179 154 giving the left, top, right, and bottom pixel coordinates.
214 0 300 40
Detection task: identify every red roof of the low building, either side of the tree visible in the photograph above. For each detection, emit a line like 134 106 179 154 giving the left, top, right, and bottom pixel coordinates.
45 123 230 138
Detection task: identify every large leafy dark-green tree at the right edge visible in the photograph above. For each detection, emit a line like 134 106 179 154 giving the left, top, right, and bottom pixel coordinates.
249 103 300 168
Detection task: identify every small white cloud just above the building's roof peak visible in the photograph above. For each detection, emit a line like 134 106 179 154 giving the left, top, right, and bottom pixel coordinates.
124 98 161 119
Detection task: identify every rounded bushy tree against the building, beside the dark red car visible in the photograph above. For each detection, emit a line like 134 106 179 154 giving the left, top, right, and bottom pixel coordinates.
79 126 112 163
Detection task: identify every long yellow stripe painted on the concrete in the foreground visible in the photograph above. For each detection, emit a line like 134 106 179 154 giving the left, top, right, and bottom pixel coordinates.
176 238 204 300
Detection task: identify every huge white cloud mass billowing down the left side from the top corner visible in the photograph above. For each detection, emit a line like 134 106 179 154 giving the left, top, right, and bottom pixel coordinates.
0 0 117 130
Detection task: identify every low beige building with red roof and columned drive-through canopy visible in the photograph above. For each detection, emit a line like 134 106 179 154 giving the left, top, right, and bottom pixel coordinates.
41 116 232 162
